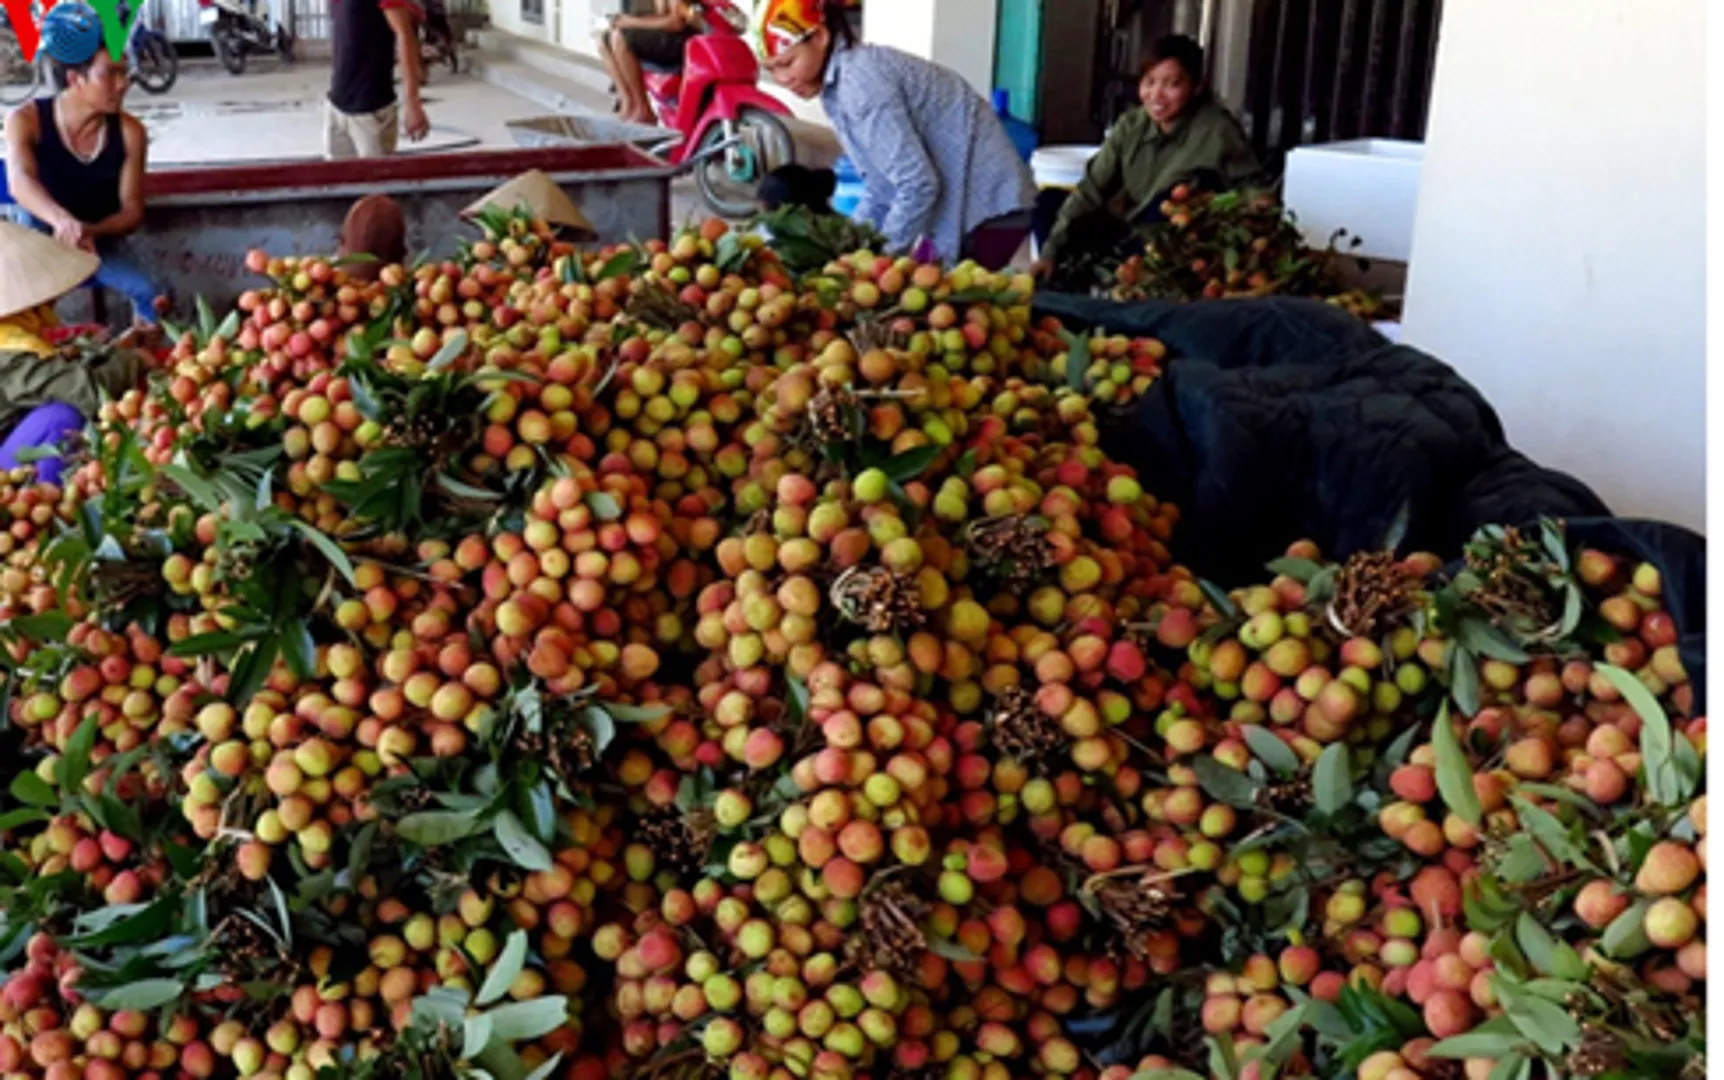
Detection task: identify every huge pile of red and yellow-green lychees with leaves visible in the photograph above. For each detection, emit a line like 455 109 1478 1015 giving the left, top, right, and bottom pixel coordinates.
0 217 1705 1080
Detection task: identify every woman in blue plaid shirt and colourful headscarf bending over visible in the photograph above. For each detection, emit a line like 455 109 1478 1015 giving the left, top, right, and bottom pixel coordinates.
753 0 1036 269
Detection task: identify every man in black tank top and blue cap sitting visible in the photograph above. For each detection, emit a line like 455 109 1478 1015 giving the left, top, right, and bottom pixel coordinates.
5 0 162 324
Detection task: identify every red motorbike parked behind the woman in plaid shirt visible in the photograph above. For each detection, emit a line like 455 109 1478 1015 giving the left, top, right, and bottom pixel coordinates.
643 0 796 217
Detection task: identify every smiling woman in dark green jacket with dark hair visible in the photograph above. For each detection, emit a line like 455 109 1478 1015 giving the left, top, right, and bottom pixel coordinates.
1036 35 1260 276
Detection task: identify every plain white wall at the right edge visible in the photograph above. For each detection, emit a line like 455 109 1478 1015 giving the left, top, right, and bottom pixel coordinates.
1405 0 1707 530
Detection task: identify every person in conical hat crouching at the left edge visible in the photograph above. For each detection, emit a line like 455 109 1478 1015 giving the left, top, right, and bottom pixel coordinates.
0 221 147 483
